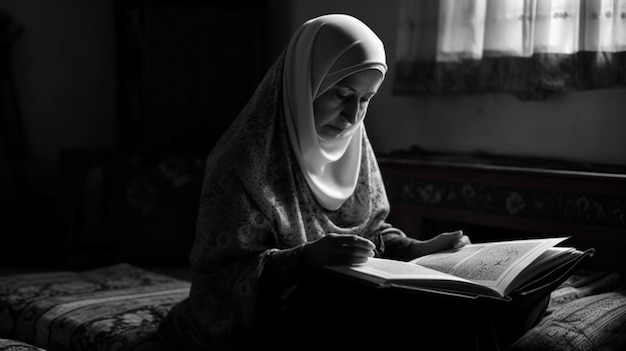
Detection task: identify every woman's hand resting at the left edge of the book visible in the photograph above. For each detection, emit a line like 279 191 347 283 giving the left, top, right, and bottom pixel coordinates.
302 233 376 271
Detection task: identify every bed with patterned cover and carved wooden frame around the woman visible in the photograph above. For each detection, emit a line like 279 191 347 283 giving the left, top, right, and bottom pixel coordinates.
0 157 626 351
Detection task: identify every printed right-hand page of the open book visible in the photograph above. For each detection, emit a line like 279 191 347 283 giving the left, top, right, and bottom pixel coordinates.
411 238 566 295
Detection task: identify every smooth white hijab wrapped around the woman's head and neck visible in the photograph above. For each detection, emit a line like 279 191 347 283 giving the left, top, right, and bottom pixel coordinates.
283 14 387 211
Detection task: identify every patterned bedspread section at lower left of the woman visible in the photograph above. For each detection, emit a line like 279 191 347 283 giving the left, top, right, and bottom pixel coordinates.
0 263 190 351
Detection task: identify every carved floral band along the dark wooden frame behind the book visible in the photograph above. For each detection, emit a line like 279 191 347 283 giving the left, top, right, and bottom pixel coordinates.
385 176 626 229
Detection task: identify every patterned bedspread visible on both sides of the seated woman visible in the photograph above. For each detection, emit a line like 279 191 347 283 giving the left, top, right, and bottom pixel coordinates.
0 263 626 351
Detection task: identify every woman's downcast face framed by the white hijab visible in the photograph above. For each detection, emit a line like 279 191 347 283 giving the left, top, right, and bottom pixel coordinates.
313 69 383 140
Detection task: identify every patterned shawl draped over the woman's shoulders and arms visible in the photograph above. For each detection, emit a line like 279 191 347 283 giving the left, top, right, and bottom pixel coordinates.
161 14 406 350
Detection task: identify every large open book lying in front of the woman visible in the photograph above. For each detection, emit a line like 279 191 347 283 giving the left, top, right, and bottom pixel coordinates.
326 237 584 298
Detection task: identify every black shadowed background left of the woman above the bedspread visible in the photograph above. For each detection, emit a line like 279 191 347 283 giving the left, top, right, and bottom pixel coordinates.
0 0 269 267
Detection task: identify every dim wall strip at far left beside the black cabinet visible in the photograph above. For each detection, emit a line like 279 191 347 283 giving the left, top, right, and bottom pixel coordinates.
0 0 118 265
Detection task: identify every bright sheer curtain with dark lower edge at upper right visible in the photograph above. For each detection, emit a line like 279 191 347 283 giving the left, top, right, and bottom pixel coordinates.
394 0 626 99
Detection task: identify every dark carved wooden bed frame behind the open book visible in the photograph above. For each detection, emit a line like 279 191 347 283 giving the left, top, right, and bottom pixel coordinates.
378 157 626 271
